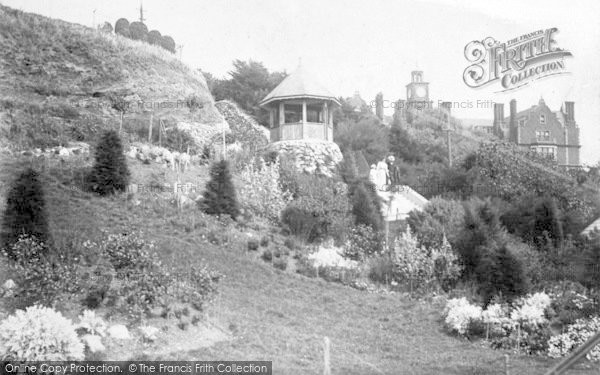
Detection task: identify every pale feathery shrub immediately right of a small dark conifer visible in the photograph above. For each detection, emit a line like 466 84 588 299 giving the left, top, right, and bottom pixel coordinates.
239 158 292 222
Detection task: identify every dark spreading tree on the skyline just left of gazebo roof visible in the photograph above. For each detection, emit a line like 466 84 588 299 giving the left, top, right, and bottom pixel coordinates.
208 60 287 125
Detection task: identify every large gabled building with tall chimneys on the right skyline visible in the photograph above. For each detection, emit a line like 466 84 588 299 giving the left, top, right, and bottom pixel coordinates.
493 99 581 167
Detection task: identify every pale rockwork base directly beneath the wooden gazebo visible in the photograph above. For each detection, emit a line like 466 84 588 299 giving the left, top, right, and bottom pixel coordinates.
267 139 343 176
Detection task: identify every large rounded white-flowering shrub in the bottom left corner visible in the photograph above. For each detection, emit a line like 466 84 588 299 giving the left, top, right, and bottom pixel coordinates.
0 306 84 361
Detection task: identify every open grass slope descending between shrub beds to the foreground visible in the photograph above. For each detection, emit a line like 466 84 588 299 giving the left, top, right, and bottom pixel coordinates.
0 154 590 375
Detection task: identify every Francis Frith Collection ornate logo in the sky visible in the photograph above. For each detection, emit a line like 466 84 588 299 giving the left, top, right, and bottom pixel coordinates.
463 27 572 92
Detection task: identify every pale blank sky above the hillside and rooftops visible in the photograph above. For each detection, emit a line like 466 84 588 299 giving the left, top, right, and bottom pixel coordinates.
0 0 600 164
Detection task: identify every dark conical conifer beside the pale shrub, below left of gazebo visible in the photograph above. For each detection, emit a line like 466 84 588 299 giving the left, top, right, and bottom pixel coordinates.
202 160 240 219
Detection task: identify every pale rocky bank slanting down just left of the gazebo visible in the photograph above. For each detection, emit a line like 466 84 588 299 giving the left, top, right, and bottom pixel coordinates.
215 100 269 149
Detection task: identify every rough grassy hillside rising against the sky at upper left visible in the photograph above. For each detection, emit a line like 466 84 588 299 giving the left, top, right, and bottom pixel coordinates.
0 5 223 148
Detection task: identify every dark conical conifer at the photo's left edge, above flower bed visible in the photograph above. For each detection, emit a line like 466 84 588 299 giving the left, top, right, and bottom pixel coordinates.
0 168 51 257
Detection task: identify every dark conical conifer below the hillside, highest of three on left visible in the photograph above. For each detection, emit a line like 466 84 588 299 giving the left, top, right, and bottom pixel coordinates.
88 130 130 195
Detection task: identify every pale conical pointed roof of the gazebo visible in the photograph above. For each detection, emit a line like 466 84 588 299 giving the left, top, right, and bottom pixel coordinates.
260 65 340 106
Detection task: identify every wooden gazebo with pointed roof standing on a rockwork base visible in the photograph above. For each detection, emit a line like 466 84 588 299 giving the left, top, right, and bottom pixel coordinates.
260 66 340 142
